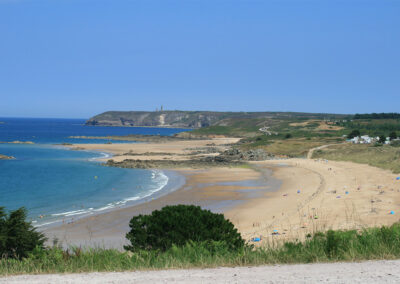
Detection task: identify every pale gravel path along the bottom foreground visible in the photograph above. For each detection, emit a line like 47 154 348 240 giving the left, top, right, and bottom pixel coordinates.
0 260 400 284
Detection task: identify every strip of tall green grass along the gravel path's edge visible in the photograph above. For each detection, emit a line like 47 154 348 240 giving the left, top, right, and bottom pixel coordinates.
0 224 400 275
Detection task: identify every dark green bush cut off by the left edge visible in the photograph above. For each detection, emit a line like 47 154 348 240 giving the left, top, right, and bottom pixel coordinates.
0 207 46 258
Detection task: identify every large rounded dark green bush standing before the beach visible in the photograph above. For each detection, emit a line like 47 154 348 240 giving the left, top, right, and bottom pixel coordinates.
124 205 245 251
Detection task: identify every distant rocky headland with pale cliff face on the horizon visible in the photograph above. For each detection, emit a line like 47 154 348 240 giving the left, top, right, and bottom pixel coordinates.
86 111 346 128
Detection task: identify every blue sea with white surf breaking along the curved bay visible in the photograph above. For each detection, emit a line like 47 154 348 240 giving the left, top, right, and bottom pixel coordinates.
0 118 189 227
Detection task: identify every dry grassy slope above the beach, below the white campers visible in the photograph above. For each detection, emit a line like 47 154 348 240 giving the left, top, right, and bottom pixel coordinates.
313 144 400 173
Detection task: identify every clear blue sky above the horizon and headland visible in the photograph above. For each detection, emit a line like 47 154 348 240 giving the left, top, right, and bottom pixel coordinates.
0 0 400 118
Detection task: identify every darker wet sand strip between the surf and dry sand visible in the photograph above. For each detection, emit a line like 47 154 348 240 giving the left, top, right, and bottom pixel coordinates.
43 165 270 249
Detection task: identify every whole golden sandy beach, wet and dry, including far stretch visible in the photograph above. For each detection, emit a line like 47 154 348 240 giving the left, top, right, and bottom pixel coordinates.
45 138 400 248
